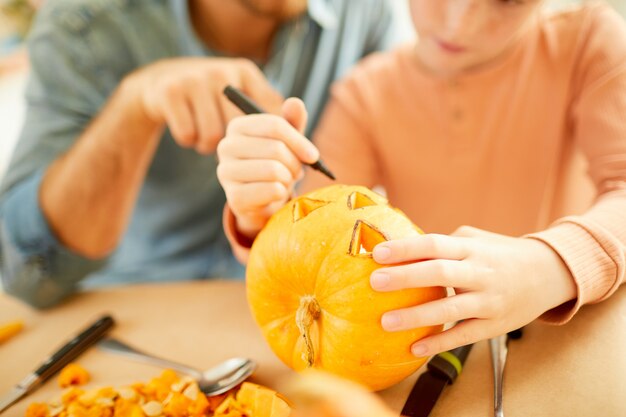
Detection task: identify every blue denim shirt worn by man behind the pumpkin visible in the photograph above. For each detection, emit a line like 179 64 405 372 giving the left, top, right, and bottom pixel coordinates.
0 0 410 307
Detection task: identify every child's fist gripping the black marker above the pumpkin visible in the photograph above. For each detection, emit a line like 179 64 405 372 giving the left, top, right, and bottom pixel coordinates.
217 98 319 237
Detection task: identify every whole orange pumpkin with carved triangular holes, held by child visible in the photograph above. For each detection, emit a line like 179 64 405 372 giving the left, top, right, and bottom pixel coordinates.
246 185 445 390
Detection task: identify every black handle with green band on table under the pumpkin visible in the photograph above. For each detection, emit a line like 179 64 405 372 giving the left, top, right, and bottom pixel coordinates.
401 344 473 417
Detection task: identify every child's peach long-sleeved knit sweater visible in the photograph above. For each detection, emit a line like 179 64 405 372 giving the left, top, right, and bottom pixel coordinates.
224 4 626 323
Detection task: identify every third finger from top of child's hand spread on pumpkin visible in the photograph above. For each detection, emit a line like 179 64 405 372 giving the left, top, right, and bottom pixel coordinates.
381 293 485 332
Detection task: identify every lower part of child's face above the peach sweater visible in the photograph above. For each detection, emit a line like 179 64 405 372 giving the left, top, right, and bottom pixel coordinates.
411 0 542 76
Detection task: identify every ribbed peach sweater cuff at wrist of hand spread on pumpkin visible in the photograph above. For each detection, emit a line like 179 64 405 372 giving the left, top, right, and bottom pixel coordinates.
525 218 624 324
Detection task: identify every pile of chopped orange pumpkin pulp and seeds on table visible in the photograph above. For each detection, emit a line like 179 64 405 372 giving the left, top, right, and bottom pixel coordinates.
26 364 291 417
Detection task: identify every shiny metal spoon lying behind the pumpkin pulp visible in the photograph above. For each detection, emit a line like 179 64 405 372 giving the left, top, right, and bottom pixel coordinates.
98 338 256 395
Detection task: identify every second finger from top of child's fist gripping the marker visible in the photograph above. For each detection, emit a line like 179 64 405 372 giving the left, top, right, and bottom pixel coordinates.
217 136 303 178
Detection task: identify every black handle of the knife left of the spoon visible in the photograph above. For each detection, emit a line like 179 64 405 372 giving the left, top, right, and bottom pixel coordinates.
34 315 115 383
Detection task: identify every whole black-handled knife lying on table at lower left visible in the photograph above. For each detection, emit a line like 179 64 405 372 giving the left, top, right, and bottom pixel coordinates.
0 315 115 414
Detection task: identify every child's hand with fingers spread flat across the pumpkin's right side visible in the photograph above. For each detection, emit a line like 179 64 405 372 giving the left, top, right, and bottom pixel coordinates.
371 227 576 356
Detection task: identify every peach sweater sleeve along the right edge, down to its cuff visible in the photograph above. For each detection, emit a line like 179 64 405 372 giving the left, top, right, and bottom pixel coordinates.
528 6 626 324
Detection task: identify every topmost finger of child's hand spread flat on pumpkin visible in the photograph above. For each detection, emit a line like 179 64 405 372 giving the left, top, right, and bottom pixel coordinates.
373 234 469 264
